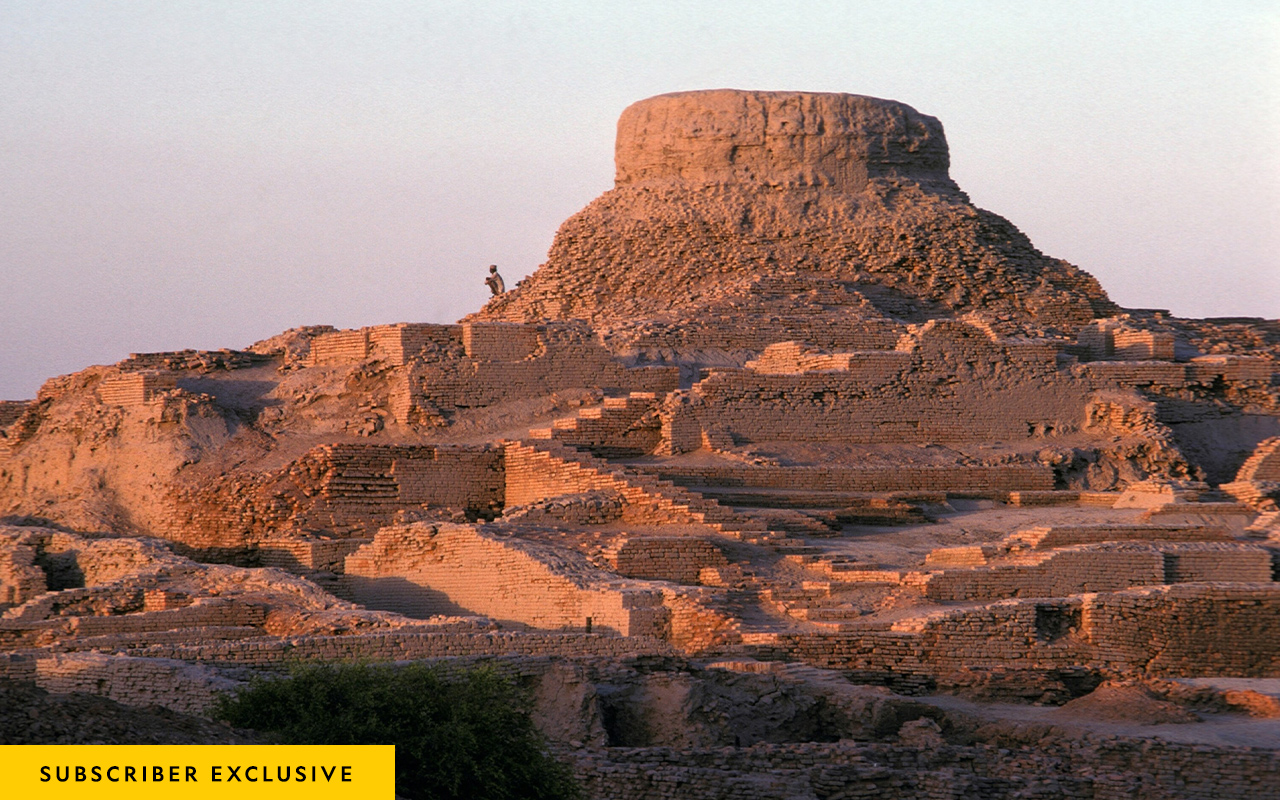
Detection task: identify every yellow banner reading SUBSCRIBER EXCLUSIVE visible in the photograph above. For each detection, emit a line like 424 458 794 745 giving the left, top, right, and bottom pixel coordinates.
0 745 396 800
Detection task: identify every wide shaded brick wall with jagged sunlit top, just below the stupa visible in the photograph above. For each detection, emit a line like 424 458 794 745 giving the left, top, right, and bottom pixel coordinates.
694 320 1088 443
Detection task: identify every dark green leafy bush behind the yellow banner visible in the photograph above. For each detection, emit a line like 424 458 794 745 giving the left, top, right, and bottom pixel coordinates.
215 664 579 800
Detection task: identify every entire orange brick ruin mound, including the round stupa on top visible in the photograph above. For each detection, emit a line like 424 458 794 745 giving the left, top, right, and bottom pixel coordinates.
0 91 1280 800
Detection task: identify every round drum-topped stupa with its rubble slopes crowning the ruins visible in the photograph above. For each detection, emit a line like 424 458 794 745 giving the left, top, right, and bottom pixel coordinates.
474 90 1115 347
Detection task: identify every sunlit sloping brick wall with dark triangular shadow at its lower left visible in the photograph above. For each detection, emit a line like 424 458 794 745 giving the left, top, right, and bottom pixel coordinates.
343 524 667 636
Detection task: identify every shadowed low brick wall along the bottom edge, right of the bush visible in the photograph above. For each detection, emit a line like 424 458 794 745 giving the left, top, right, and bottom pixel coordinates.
566 736 1280 800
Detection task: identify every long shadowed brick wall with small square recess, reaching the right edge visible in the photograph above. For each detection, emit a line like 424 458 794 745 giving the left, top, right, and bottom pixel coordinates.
762 584 1280 680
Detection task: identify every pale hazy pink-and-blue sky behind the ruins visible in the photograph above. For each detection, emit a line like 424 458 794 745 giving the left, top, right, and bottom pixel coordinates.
0 0 1280 398
